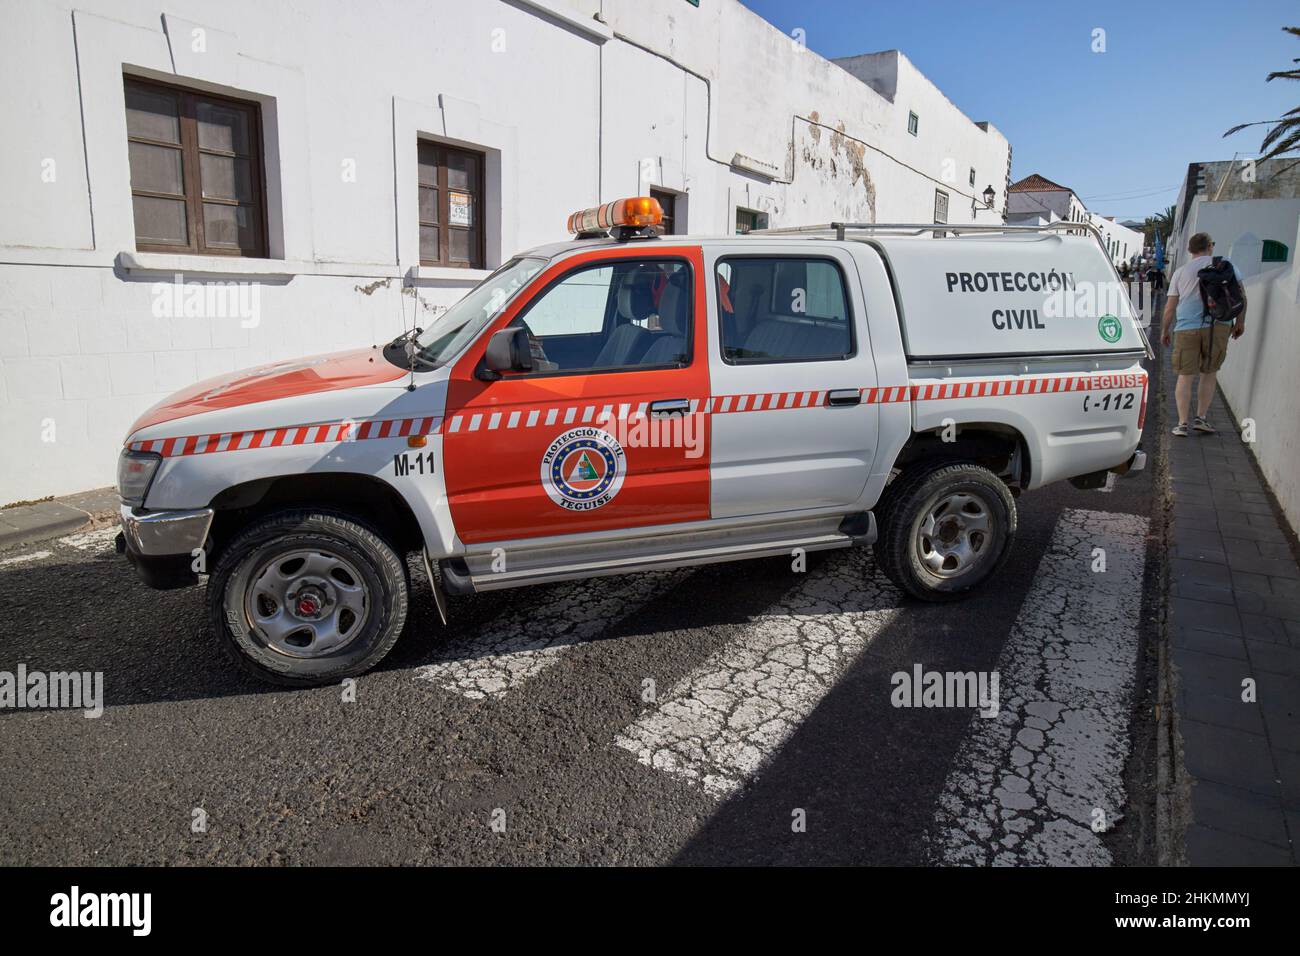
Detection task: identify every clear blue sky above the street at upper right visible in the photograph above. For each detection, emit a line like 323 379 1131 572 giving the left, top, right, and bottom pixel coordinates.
738 0 1300 219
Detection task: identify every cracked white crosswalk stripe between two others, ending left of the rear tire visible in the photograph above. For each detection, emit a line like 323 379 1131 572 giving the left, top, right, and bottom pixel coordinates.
615 548 902 797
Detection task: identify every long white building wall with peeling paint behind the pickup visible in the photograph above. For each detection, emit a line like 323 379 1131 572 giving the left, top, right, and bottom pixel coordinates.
0 0 1009 503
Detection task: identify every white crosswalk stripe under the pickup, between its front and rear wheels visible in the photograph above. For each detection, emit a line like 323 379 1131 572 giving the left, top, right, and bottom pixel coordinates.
416 570 692 700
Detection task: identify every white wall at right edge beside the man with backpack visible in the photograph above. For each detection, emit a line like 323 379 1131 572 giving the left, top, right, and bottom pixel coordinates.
1218 214 1300 528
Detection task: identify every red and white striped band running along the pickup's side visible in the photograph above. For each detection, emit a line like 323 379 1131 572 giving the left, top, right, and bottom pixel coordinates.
130 372 1147 458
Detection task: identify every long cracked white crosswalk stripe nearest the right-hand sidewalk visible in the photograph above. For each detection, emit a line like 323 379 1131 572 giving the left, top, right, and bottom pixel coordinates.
931 510 1148 866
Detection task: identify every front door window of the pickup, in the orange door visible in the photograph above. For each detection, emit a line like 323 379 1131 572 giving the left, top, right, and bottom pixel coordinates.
511 259 693 375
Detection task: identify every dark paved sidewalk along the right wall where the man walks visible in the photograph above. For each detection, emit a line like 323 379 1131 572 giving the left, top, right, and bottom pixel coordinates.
1160 350 1300 866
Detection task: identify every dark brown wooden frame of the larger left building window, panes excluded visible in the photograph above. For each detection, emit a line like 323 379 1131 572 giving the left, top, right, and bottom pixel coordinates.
122 74 269 259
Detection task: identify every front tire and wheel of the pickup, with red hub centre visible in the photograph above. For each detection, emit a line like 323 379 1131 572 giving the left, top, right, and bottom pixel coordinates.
208 511 408 687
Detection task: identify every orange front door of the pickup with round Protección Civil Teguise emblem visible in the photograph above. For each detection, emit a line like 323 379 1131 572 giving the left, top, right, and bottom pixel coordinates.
443 242 710 544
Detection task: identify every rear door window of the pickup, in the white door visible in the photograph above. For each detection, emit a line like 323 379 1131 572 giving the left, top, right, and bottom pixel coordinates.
714 256 854 364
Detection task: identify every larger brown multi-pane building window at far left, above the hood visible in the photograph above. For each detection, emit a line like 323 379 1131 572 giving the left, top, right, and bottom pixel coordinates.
125 78 267 256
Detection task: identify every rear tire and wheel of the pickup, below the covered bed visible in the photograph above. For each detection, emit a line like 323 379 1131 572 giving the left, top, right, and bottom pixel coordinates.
875 462 1017 602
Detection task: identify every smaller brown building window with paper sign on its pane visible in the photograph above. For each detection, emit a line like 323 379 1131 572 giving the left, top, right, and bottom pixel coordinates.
419 139 484 269
